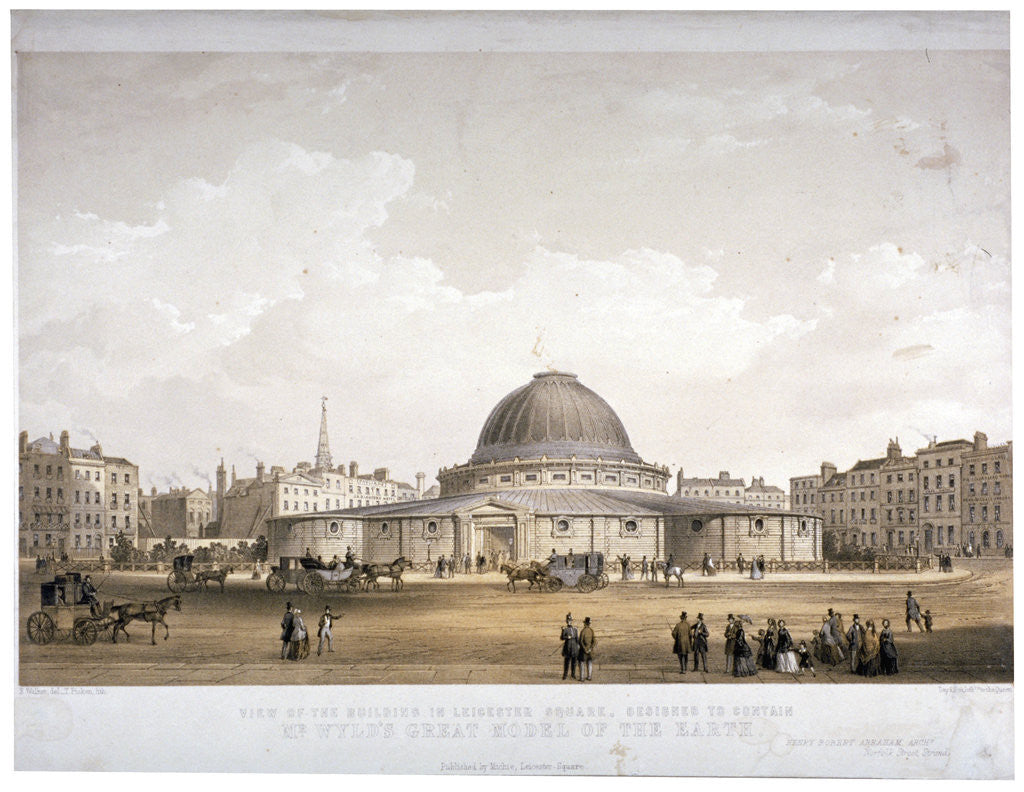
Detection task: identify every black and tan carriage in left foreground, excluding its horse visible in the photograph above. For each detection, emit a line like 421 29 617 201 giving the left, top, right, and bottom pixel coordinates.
27 572 117 647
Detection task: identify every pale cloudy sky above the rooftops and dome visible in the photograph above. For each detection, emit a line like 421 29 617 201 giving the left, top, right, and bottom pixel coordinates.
14 13 1012 490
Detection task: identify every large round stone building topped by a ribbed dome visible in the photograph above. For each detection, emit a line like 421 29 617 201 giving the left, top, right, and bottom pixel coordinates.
267 372 821 565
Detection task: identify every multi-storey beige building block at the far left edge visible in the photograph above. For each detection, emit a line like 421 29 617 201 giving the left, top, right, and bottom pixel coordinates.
18 430 138 557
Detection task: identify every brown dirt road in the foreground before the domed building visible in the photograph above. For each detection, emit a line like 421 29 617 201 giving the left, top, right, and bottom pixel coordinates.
18 558 1013 685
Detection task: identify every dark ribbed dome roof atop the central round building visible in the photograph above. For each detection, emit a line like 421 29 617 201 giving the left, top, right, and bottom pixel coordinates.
470 371 641 464
